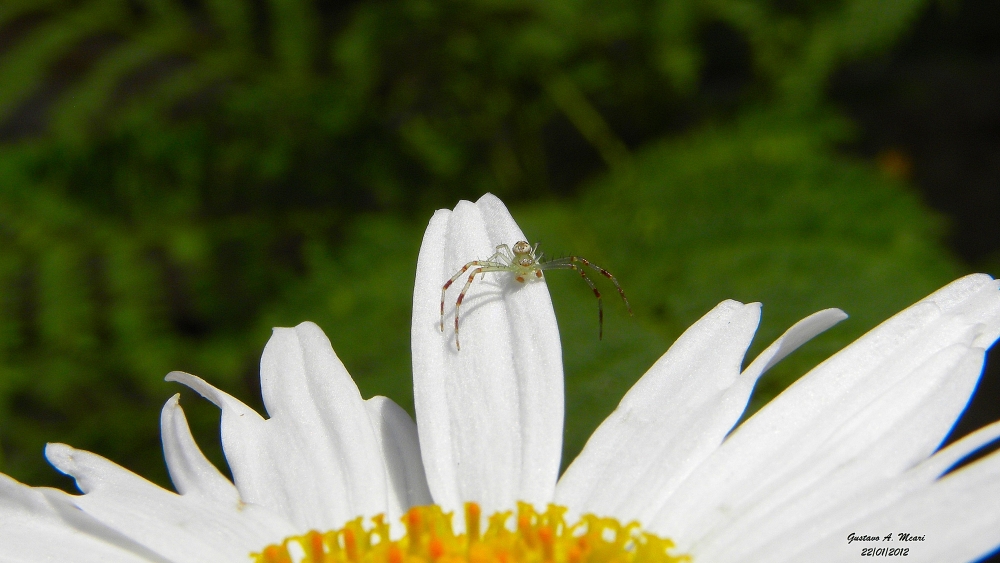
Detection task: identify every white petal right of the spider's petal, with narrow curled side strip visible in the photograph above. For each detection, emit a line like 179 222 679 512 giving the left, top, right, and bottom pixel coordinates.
556 301 846 522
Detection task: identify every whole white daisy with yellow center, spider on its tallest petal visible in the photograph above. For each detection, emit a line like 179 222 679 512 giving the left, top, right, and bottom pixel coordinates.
0 195 1000 563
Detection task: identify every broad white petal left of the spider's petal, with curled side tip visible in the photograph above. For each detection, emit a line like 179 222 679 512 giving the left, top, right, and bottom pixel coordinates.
167 323 388 530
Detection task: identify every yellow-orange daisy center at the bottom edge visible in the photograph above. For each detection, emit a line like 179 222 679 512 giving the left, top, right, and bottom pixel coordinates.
251 502 691 563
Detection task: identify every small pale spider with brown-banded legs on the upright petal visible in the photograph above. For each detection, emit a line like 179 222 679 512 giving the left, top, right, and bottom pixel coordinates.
441 240 632 350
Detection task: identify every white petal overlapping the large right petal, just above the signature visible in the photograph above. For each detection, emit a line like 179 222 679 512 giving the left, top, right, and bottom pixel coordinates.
695 345 983 561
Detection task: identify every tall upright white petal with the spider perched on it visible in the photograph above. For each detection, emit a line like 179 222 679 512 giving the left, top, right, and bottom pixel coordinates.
411 194 563 513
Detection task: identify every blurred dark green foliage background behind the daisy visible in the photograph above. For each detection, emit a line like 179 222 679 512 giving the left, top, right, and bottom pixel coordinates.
0 0 1000 506
